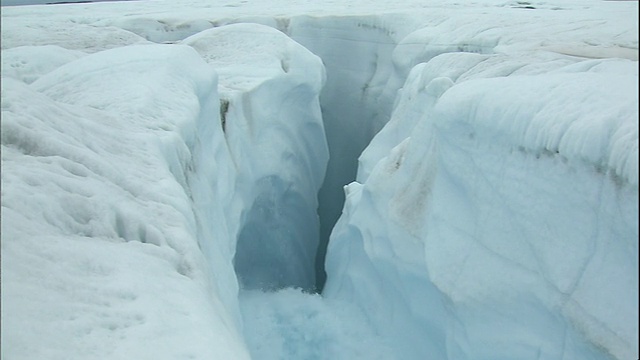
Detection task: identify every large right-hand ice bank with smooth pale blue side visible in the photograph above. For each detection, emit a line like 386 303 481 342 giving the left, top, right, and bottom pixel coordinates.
324 53 638 359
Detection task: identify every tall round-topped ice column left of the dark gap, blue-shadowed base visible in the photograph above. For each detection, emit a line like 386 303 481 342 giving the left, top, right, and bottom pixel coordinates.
182 24 328 290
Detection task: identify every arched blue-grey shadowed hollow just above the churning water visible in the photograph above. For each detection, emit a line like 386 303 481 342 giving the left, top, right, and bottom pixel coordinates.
234 176 318 291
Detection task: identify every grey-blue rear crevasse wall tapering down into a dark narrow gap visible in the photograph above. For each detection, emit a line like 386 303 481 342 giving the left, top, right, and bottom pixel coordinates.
286 16 408 290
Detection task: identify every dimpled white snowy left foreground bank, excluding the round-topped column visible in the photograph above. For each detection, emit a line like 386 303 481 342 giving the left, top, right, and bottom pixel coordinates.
2 45 248 359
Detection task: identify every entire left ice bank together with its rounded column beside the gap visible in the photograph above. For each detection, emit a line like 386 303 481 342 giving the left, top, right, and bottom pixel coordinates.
2 24 328 359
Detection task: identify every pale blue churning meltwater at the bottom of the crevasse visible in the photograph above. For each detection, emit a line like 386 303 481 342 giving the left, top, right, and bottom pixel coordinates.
240 288 393 360
